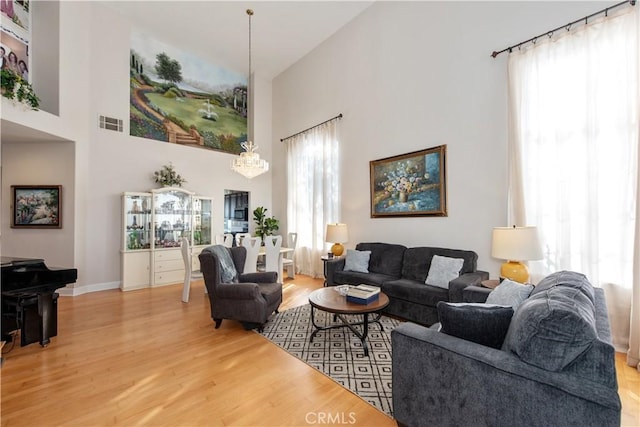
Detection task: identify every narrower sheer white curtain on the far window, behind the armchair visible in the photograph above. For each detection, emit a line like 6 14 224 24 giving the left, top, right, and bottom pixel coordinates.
286 120 340 277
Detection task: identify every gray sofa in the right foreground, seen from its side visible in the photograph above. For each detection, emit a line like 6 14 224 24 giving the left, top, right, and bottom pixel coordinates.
392 271 621 426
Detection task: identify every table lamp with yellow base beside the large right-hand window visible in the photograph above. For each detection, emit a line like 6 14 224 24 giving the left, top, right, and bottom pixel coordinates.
491 225 542 283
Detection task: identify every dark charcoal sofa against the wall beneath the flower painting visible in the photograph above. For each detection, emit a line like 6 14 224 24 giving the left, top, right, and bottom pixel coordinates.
326 243 489 326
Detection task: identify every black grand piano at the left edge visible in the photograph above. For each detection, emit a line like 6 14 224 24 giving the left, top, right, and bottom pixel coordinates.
0 257 78 347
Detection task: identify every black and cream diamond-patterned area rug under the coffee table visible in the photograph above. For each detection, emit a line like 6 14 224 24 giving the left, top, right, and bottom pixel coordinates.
262 304 400 416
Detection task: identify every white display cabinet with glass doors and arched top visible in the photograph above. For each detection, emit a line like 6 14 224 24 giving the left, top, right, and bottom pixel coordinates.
120 187 213 290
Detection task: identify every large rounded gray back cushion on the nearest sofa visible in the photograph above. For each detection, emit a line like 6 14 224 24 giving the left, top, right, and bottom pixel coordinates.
502 278 597 371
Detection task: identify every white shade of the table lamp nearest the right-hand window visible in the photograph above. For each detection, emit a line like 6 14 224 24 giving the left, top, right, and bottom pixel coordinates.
491 227 543 261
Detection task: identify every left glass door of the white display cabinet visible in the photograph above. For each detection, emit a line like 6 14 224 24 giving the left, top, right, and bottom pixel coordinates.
122 193 151 251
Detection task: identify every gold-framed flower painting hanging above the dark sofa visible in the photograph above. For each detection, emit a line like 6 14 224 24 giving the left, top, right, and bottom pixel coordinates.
369 145 447 218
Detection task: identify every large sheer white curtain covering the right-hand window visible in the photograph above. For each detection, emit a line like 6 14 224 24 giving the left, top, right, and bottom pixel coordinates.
508 7 640 366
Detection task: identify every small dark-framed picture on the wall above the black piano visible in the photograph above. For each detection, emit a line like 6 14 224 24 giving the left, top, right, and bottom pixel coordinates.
11 185 62 228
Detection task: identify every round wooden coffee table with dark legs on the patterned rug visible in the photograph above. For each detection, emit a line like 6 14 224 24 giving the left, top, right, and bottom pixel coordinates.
309 286 389 356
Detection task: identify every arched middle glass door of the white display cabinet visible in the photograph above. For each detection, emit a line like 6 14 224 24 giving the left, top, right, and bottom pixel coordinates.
152 189 192 249
